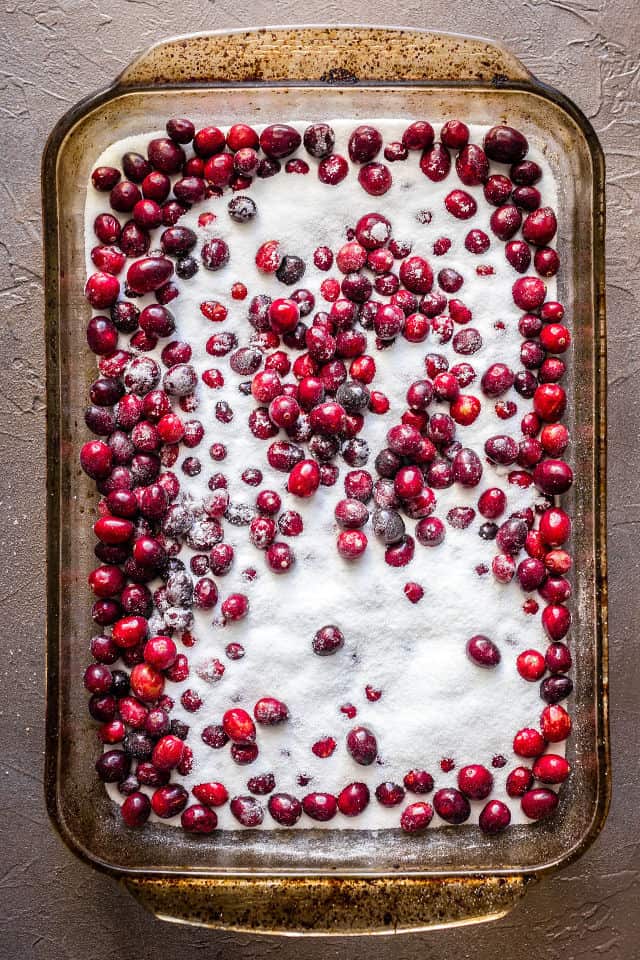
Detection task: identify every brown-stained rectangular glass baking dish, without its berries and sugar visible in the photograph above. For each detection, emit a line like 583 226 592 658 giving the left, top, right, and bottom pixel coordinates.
42 27 609 935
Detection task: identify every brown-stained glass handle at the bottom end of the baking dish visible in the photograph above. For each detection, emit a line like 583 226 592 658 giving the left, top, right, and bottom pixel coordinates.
122 876 534 936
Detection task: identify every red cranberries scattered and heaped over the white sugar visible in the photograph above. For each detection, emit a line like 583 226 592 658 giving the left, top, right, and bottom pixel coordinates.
80 119 573 834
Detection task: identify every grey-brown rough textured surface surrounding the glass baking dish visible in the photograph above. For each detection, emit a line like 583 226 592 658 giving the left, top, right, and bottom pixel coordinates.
0 0 640 960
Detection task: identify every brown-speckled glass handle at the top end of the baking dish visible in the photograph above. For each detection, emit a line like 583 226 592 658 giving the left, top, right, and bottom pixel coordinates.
117 26 532 88
